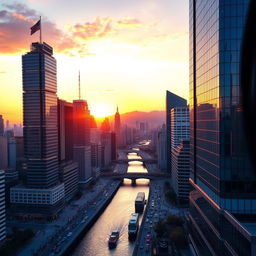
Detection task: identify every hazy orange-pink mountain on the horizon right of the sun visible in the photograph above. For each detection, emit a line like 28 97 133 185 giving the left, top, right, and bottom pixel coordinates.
109 111 165 128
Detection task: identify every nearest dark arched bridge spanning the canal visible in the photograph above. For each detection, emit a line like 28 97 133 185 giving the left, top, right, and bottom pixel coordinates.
101 172 171 181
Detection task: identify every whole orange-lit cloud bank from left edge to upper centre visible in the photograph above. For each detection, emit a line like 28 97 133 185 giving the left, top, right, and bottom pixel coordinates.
0 3 145 57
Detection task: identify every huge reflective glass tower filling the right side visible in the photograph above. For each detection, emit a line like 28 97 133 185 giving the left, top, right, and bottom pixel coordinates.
189 0 256 256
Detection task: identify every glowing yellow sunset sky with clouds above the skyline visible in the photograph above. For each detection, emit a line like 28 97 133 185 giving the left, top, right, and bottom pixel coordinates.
0 0 189 123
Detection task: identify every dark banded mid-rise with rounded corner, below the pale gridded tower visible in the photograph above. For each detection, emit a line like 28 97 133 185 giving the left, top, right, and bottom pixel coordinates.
172 139 190 204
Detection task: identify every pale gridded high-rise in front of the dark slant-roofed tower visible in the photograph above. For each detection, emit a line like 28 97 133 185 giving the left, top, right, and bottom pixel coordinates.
171 107 190 150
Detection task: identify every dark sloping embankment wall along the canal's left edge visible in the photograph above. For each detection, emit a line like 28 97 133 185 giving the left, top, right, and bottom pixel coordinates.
56 181 122 256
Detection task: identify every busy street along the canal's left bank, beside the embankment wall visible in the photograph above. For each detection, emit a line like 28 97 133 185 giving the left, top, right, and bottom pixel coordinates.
15 179 122 256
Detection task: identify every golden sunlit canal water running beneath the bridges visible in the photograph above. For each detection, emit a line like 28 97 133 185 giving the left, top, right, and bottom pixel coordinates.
72 153 149 256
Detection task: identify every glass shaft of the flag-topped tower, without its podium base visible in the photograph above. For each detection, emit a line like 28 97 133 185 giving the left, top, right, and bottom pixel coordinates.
22 43 58 188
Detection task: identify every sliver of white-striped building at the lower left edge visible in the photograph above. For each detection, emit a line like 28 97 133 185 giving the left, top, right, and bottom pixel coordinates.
0 170 6 242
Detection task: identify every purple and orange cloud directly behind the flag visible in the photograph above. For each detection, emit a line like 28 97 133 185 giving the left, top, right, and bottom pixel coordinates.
0 3 78 54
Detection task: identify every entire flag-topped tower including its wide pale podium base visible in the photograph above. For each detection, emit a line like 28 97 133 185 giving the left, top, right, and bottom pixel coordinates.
10 43 64 215
